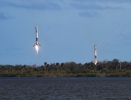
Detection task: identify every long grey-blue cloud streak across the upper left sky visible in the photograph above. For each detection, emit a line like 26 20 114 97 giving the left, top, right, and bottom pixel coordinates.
0 2 61 10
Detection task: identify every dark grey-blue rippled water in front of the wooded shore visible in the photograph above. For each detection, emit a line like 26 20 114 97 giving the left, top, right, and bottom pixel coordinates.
0 77 131 100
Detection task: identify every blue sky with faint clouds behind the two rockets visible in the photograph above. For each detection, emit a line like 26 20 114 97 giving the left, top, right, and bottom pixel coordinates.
0 0 131 65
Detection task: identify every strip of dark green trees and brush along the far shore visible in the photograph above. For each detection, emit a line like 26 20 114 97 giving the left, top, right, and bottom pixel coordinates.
0 59 131 77
